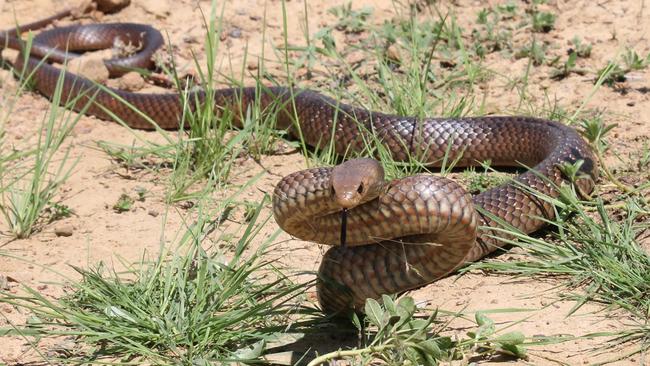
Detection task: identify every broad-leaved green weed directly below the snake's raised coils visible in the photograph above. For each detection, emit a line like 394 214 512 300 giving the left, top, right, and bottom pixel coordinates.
308 295 527 366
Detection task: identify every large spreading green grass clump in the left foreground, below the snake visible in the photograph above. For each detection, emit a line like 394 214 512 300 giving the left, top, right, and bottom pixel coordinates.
0 194 312 364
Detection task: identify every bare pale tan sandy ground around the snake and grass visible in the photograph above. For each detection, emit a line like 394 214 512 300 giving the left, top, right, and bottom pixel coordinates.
0 0 650 365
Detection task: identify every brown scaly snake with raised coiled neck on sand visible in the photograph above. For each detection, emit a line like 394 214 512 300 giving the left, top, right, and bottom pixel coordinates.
0 3 598 313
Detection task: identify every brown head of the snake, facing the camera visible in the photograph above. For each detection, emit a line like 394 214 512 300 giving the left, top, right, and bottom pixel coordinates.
330 158 384 209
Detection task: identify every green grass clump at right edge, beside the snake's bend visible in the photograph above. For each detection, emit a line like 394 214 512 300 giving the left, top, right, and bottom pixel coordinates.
465 172 650 360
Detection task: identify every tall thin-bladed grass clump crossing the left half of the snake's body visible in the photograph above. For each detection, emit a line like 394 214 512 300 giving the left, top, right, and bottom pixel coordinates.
85 1 285 203
